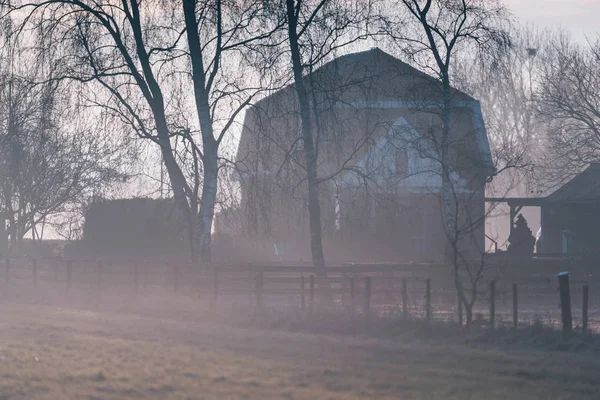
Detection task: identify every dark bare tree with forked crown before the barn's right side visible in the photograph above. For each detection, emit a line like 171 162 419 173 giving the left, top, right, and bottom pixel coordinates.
390 0 508 323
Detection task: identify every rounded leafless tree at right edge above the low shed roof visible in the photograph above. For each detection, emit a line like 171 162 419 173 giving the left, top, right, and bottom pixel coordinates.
535 33 600 190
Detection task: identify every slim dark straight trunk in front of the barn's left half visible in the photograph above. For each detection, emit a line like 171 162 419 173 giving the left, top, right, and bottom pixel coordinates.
286 0 326 277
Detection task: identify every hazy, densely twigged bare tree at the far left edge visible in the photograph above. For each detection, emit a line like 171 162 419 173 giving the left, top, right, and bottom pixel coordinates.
0 23 128 245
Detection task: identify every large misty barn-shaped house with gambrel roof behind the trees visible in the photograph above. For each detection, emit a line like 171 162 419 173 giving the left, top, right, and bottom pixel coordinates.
223 48 493 262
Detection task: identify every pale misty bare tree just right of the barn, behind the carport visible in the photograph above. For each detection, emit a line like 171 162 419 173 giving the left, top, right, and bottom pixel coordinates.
453 26 548 246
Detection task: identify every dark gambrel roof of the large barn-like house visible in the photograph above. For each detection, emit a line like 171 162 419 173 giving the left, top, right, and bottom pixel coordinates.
237 48 494 176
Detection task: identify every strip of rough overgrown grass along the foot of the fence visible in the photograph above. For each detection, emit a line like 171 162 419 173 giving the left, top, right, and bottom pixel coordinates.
0 276 600 353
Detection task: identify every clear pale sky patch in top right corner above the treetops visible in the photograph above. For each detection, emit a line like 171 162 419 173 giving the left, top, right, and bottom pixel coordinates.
504 0 600 42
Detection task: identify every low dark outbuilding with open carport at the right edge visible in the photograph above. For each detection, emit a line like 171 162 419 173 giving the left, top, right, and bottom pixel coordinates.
486 163 600 256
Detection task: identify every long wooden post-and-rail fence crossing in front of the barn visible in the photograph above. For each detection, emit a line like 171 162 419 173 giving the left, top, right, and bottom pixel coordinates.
0 258 600 333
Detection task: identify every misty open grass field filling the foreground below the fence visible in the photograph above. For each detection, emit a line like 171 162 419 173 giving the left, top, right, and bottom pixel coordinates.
0 303 600 400
